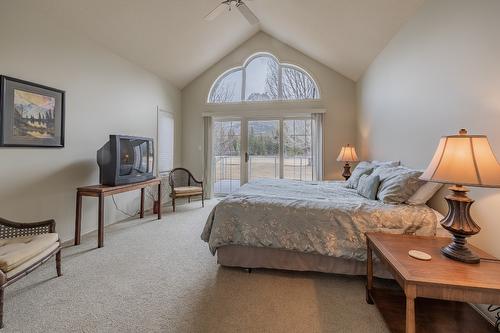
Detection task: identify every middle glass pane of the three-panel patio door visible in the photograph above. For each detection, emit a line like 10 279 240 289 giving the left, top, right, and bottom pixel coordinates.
245 119 281 181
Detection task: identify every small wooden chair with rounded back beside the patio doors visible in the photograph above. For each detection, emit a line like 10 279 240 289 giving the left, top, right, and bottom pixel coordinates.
168 168 205 212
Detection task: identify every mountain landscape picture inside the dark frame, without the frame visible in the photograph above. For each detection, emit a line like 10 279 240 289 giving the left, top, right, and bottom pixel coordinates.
13 89 56 139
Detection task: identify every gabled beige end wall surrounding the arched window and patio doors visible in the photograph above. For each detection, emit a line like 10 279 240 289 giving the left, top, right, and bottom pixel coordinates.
182 32 356 179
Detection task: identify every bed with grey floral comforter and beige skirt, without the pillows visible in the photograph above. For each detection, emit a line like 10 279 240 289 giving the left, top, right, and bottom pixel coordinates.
201 179 442 277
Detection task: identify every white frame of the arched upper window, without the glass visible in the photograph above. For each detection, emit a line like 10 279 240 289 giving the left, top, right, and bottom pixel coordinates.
206 52 322 105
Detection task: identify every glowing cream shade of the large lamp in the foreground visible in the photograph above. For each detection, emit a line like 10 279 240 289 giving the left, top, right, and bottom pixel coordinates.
420 129 500 187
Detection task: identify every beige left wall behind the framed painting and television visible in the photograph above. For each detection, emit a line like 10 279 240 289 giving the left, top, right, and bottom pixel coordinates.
0 0 181 240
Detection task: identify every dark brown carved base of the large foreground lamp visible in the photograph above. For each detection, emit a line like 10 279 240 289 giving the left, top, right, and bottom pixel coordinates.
441 185 481 264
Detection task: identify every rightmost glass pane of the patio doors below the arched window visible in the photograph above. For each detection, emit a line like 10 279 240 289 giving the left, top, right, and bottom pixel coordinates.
283 119 312 180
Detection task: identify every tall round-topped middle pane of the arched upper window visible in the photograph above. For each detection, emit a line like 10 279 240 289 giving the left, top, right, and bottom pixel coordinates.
245 56 279 101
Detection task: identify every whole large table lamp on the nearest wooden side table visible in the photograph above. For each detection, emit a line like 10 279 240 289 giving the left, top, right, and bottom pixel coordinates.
420 129 500 264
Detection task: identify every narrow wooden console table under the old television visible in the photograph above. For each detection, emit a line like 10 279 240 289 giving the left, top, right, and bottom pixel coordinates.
75 178 161 247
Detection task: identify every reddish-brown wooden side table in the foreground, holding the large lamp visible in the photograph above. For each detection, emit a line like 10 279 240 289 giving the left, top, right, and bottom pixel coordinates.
366 233 500 333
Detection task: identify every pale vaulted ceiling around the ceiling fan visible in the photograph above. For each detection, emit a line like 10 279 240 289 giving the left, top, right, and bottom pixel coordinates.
43 0 425 88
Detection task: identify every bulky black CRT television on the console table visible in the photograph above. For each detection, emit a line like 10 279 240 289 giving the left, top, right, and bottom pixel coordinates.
97 135 155 186
